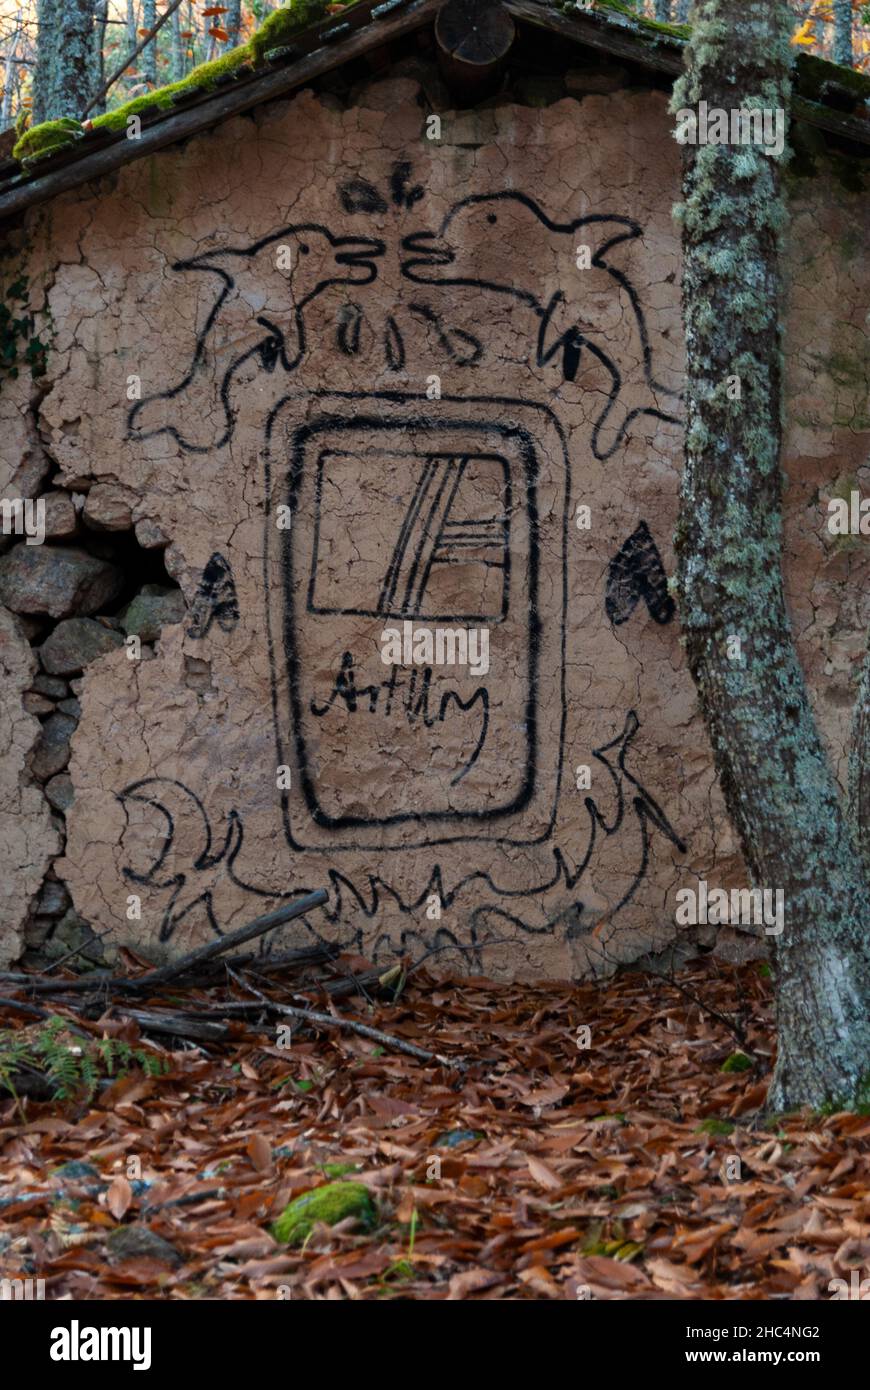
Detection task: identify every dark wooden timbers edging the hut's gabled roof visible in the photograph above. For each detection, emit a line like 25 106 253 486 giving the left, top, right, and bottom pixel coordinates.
0 0 870 220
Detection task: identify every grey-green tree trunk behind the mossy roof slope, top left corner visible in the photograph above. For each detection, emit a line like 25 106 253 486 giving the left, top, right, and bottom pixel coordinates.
33 0 95 125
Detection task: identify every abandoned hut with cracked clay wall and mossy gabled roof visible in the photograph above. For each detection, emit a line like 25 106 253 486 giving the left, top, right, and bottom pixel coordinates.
0 0 870 977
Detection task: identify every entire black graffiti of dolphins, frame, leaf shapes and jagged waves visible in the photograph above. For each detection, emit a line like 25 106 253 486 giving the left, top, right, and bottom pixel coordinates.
118 160 685 945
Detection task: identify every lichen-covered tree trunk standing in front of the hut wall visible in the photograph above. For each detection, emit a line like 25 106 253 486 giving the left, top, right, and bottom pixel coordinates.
674 0 870 1109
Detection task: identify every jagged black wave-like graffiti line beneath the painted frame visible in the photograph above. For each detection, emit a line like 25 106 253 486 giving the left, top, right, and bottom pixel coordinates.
117 710 688 967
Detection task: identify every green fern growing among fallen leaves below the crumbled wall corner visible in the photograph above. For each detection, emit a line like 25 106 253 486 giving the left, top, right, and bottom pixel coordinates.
0 1016 167 1101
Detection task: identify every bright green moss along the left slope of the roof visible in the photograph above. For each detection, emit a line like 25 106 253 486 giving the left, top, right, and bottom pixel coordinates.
13 0 357 168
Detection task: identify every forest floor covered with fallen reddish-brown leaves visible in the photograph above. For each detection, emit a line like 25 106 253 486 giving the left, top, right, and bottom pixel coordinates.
0 962 870 1300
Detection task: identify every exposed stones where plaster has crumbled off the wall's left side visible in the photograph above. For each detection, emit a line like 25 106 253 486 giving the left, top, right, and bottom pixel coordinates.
0 358 183 966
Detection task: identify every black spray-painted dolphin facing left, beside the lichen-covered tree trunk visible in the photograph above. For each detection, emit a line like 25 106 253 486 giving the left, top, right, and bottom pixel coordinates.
402 190 678 459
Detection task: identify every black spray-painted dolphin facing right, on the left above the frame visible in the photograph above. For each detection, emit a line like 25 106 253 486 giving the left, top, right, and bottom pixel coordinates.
126 222 385 453
